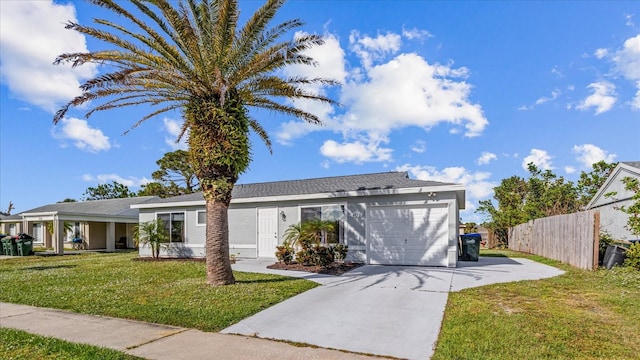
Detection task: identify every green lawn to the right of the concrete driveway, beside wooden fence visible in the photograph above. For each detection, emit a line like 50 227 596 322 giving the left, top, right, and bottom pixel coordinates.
433 250 640 360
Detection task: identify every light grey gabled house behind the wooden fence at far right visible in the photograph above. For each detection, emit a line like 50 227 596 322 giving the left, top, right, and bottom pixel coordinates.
586 161 640 240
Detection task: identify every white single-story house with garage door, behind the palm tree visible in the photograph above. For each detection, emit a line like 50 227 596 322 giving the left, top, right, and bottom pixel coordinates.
132 172 465 267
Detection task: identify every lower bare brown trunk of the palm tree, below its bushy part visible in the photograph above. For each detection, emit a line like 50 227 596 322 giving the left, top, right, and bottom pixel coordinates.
205 196 235 286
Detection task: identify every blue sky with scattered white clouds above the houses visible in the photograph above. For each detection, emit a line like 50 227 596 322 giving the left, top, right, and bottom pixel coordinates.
0 0 640 221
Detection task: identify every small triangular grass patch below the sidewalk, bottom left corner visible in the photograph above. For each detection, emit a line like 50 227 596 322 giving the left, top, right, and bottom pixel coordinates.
0 328 140 360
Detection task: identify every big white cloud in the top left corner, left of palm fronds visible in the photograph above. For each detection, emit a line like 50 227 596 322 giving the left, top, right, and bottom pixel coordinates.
0 1 97 112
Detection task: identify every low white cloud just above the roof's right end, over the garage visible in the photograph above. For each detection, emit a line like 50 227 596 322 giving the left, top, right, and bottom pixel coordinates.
396 164 497 201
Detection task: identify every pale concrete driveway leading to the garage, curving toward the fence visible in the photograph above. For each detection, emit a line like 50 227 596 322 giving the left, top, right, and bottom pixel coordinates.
222 257 563 359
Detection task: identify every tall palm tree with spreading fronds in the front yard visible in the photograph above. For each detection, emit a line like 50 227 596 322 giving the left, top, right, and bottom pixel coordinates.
54 0 334 285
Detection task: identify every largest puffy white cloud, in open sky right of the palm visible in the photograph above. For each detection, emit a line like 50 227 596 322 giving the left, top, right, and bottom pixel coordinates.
340 54 488 137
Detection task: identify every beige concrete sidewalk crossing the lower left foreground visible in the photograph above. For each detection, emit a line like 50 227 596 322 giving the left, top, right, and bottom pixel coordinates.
0 302 372 360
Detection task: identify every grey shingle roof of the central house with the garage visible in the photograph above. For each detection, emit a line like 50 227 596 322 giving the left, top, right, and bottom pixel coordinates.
152 172 455 204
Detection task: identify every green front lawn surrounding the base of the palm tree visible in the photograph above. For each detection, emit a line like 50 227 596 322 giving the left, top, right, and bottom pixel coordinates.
0 253 317 331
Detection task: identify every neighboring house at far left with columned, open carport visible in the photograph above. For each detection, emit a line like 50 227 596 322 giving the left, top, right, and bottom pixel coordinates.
13 196 159 253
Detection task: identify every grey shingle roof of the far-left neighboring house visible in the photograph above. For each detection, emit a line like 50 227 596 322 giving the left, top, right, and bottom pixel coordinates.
21 196 160 217
